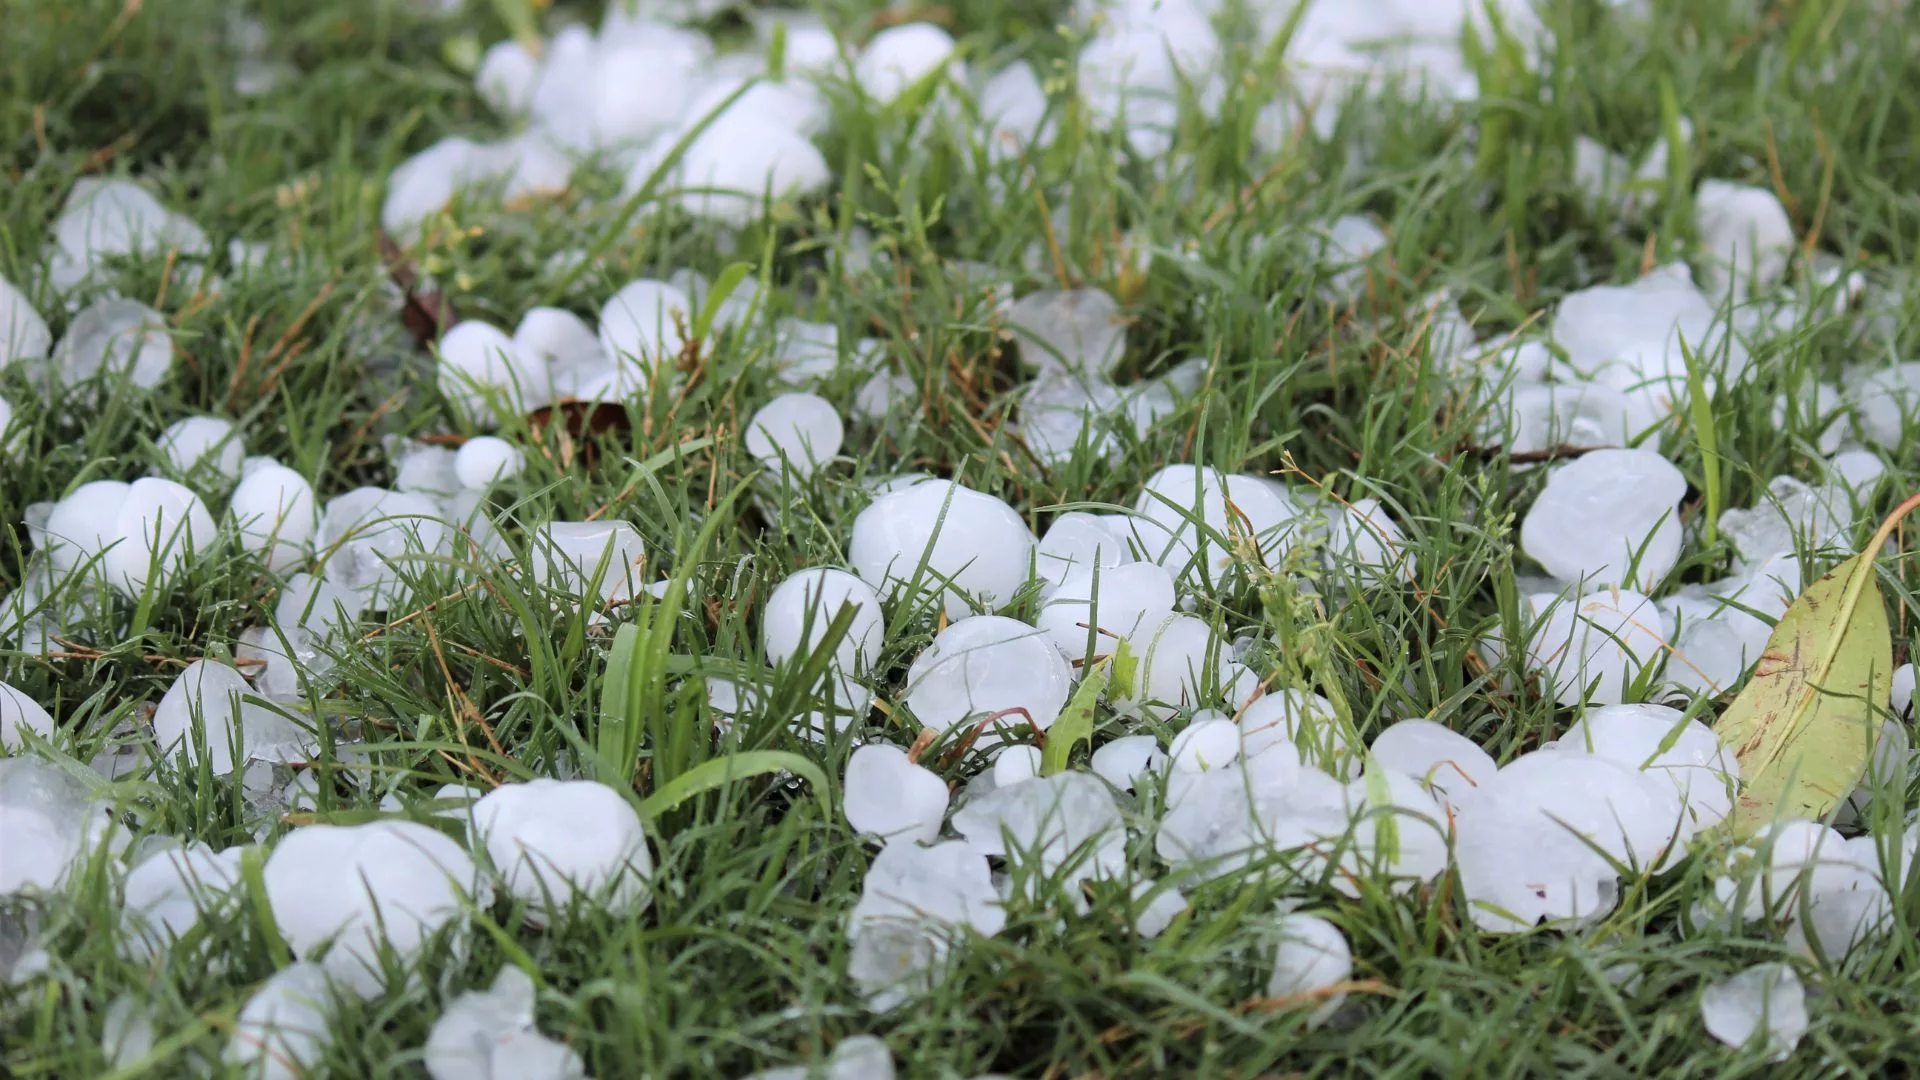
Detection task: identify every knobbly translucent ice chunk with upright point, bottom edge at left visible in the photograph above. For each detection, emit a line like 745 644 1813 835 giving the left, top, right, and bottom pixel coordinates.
422 965 586 1080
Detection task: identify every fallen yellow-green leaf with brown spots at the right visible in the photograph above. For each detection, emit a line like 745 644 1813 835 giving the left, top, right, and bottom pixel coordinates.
1715 544 1893 836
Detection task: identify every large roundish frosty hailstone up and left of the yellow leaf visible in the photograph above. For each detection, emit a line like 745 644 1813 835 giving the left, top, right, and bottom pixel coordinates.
1521 450 1686 588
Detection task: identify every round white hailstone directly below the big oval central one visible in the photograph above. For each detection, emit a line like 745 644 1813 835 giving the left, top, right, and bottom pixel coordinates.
906 615 1073 746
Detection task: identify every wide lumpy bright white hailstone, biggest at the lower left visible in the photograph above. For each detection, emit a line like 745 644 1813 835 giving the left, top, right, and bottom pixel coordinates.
261 821 492 995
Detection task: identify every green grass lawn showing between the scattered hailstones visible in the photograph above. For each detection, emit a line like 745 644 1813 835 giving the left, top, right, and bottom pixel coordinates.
11 0 1920 1080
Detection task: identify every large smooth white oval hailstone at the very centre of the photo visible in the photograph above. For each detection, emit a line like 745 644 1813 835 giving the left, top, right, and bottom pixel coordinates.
849 480 1035 619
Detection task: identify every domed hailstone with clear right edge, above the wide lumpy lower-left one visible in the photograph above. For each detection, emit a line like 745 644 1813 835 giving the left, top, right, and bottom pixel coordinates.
154 659 313 776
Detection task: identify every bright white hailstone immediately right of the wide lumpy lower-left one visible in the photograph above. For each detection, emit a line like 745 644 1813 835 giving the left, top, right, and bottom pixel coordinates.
472 778 653 926
